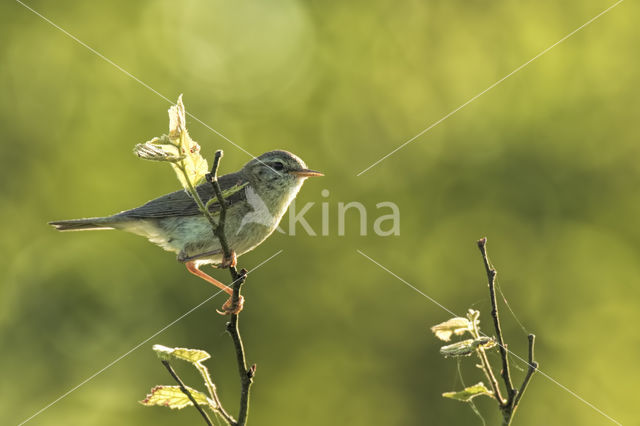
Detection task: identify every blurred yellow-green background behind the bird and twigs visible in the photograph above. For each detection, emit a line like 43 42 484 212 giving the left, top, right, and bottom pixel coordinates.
0 0 640 425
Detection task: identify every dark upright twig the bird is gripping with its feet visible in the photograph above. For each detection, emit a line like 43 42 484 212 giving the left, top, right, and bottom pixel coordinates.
205 150 256 426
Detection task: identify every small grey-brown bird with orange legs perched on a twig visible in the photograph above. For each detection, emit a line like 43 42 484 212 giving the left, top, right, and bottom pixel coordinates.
49 150 323 313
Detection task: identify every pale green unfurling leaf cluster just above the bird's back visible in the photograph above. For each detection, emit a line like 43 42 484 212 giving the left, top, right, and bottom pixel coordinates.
133 95 209 189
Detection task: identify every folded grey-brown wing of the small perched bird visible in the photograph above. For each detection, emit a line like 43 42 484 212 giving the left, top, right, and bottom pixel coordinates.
115 173 249 218
